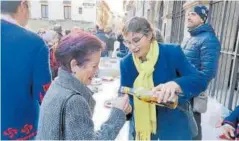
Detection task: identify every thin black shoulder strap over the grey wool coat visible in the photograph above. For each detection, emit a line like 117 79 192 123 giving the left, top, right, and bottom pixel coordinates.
58 94 79 140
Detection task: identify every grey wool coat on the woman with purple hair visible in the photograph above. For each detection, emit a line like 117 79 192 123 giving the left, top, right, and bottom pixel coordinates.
36 68 126 140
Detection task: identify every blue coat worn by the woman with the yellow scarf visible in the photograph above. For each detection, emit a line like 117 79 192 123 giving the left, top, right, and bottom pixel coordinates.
120 44 207 140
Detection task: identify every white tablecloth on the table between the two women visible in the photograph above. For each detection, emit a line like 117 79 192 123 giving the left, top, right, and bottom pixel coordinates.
93 57 128 140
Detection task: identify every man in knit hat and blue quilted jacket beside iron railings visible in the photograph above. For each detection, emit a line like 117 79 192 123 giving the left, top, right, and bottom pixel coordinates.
182 5 221 140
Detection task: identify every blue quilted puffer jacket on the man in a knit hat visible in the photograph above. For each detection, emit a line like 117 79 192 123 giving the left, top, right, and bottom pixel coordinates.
182 24 221 81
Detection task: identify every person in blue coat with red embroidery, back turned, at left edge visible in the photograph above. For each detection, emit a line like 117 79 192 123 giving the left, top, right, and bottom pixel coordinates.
1 0 51 140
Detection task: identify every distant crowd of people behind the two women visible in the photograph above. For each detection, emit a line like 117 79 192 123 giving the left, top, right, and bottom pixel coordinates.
37 24 135 78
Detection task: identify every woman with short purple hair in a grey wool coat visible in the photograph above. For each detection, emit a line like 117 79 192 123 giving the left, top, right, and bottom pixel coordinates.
37 31 132 140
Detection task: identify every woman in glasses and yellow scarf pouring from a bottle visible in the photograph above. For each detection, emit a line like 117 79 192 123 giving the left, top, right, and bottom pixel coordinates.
120 17 207 140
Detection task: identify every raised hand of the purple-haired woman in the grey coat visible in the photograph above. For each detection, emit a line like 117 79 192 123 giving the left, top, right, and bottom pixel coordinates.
111 94 132 114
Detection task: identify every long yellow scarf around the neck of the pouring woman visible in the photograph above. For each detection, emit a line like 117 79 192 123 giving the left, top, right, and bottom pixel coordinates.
133 41 159 140
